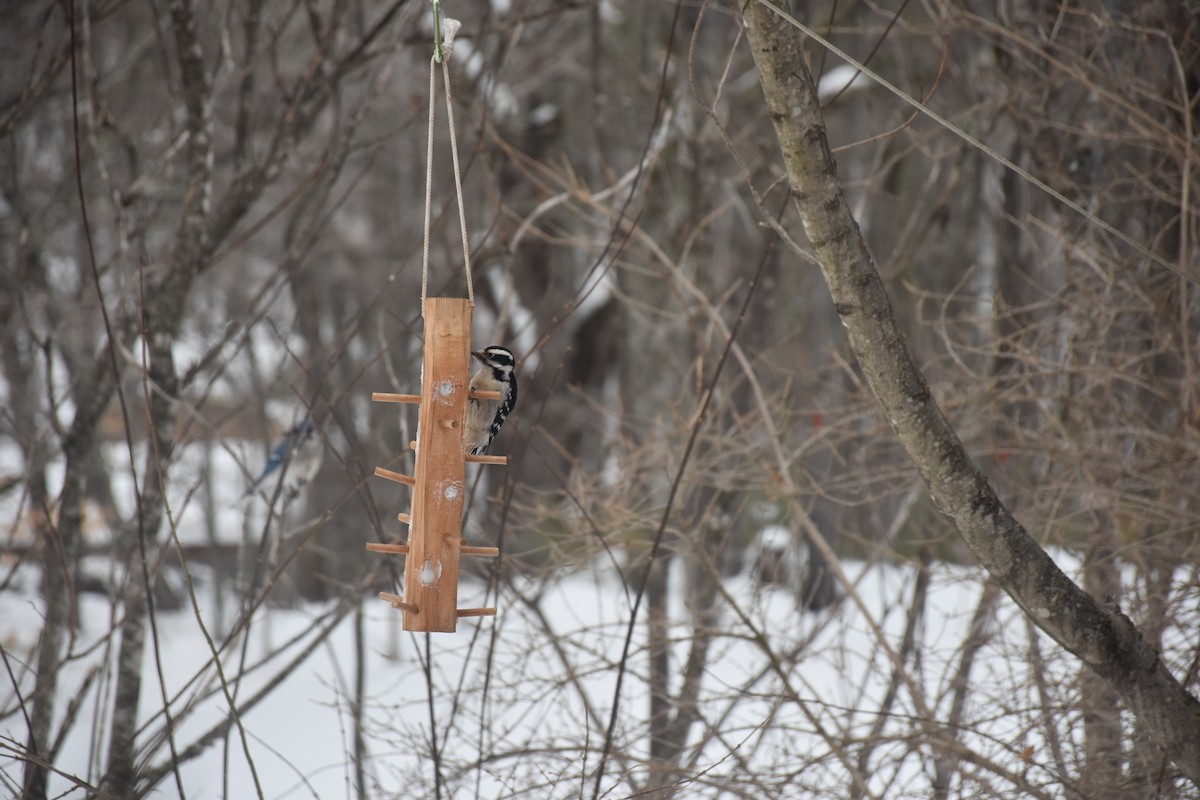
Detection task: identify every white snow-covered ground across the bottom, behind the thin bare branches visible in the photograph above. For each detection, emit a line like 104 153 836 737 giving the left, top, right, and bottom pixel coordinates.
0 544 1094 800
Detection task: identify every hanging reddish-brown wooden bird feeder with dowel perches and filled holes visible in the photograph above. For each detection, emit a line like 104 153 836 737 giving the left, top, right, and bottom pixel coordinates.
367 297 508 632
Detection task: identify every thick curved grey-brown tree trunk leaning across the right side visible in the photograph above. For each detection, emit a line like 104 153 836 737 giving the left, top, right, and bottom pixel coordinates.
742 0 1200 786
